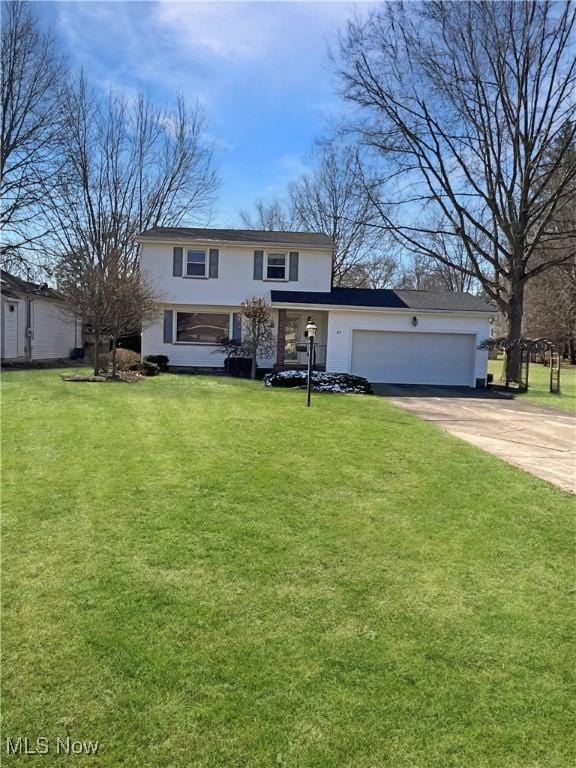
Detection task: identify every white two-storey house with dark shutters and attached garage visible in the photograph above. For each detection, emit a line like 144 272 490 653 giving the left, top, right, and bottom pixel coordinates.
138 228 494 387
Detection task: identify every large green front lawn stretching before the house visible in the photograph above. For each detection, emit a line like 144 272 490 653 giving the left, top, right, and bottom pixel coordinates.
1 371 576 768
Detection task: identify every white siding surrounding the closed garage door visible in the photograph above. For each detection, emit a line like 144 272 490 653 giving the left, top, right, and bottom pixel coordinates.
326 310 490 386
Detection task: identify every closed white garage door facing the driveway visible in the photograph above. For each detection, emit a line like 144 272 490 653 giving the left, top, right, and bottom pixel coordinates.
351 331 476 387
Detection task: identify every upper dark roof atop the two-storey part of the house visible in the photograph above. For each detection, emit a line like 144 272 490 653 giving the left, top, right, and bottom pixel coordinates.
139 227 334 248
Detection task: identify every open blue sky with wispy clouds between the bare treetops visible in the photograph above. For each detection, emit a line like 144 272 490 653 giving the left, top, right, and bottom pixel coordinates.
35 0 368 226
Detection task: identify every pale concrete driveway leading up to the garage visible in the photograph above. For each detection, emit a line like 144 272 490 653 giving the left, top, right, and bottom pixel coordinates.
374 384 576 493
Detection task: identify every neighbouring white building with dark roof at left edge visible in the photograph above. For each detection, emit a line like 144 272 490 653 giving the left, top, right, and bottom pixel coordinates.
0 270 82 363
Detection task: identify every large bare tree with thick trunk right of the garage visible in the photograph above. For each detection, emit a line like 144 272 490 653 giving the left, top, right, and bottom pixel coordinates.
339 0 576 379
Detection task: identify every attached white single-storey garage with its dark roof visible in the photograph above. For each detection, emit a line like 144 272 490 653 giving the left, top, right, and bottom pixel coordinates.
272 288 495 387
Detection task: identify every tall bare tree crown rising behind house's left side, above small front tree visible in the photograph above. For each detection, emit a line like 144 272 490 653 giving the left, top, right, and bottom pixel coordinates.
44 70 217 272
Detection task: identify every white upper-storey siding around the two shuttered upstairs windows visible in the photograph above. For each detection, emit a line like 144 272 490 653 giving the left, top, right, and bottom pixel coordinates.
140 243 332 306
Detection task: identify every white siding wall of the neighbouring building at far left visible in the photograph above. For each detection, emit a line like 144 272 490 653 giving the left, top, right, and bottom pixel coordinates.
32 298 78 360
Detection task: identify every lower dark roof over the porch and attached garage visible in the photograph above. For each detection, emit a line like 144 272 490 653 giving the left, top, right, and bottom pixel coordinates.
272 288 495 312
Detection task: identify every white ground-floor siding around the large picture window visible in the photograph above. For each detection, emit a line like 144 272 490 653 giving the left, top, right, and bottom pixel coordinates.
142 304 278 368
